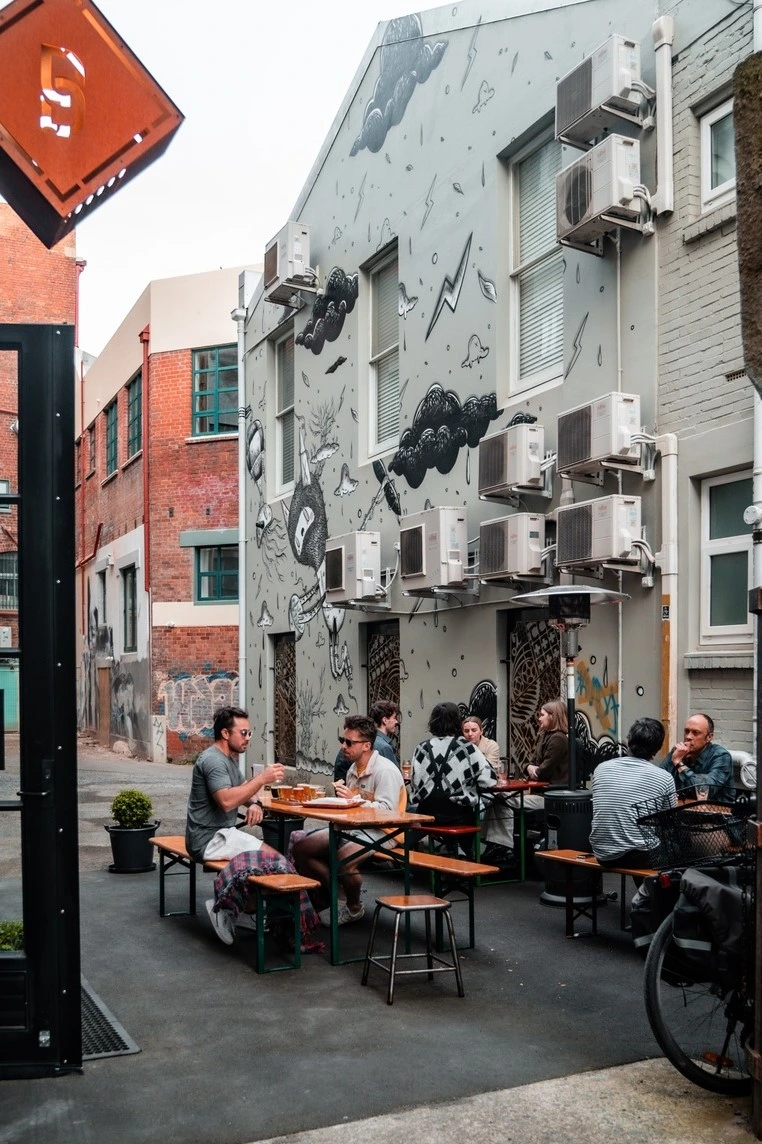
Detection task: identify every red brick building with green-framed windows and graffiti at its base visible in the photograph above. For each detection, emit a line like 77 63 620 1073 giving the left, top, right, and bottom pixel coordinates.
77 268 259 760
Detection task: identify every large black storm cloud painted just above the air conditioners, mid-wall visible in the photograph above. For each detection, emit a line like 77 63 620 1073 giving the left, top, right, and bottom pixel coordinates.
389 384 498 488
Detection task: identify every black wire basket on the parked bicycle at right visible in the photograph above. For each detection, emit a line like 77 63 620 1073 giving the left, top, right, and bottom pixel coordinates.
636 800 745 869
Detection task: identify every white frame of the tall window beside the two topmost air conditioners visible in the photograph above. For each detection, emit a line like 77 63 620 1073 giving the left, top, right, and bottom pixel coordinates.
508 130 564 394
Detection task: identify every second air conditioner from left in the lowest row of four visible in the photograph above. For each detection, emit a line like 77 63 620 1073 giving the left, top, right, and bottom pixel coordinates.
399 508 468 589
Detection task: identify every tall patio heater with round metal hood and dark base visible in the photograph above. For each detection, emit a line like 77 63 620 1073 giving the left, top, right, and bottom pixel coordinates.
513 585 630 906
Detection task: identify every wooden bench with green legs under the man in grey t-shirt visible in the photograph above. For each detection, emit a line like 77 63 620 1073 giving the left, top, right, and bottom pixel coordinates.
151 834 320 974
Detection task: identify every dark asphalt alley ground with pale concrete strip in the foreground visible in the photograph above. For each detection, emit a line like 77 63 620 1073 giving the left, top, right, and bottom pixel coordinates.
0 745 753 1144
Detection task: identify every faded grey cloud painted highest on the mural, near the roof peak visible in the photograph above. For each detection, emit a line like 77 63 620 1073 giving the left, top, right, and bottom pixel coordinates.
349 13 447 156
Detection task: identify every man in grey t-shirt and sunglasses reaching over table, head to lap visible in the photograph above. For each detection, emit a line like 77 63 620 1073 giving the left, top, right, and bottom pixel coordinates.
185 707 285 861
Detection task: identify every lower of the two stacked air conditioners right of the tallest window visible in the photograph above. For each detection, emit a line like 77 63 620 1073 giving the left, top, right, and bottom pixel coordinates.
556 135 641 244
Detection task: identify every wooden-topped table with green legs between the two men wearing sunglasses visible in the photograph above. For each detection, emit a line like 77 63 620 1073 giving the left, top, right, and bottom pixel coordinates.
257 792 434 966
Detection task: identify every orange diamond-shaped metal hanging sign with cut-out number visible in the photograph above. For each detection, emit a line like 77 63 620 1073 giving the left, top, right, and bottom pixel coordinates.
0 0 183 247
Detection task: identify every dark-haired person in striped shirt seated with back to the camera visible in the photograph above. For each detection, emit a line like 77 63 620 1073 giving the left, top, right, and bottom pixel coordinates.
590 718 676 868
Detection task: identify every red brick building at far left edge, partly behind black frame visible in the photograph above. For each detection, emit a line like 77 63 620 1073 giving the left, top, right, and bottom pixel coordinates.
0 202 78 730
